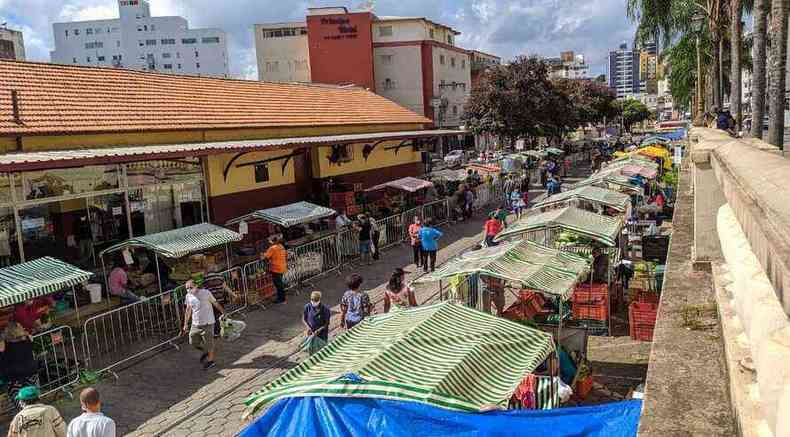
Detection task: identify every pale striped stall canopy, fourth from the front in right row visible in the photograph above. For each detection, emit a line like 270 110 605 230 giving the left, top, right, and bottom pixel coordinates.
534 185 631 217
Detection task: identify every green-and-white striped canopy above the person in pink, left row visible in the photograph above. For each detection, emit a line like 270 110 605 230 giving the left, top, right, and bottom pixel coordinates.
100 223 242 258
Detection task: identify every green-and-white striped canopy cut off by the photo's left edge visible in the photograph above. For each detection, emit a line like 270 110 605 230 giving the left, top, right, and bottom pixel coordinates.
0 256 92 307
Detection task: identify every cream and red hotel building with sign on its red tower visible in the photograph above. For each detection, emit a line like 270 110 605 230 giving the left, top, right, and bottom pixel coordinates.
254 7 472 127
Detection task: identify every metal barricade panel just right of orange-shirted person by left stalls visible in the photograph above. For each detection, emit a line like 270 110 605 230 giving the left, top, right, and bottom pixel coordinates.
284 235 341 288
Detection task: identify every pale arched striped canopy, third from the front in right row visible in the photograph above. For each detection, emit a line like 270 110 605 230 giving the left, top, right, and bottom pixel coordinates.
496 207 623 247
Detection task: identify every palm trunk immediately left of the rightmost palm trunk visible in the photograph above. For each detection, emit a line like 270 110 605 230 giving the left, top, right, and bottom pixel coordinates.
751 0 770 139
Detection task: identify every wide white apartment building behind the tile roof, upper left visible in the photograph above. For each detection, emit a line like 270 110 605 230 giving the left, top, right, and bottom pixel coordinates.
50 0 229 77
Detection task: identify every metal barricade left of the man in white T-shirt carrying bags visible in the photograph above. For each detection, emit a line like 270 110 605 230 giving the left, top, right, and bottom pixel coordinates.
82 286 186 372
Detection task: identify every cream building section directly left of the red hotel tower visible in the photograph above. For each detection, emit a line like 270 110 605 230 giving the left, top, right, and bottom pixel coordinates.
254 21 310 82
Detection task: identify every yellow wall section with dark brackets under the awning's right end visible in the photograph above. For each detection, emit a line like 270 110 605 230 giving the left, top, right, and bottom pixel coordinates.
312 140 421 178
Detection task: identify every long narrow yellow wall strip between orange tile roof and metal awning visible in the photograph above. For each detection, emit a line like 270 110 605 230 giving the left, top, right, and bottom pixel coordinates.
0 124 423 153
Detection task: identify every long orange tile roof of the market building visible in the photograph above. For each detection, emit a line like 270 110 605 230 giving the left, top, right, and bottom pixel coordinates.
0 61 430 136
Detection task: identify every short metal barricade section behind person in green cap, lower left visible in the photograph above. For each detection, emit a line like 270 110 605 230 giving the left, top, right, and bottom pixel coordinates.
33 326 80 396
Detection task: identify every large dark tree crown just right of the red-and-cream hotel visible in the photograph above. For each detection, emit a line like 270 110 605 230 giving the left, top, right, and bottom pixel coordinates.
463 56 616 141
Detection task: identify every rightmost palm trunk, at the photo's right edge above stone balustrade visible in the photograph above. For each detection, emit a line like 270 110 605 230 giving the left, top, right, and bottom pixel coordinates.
767 0 788 147
